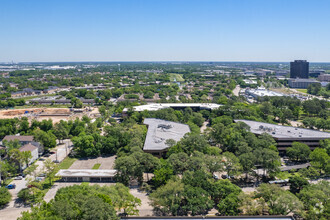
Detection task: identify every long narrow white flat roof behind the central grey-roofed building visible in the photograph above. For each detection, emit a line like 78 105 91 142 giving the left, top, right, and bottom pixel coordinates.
123 103 221 112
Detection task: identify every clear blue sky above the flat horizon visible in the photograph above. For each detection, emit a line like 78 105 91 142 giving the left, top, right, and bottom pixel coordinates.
0 0 330 62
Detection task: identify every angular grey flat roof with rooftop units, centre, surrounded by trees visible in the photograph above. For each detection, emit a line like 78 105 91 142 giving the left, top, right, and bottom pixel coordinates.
143 118 190 151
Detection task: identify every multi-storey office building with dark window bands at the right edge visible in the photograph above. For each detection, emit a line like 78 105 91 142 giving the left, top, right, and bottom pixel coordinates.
235 120 330 151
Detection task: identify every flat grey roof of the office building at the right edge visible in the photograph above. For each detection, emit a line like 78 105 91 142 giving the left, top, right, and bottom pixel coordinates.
235 120 330 140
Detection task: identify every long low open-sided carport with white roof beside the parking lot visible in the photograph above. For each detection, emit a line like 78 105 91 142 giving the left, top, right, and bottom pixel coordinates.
56 169 117 182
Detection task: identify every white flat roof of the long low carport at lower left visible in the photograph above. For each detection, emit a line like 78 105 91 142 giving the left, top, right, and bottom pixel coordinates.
56 169 117 177
